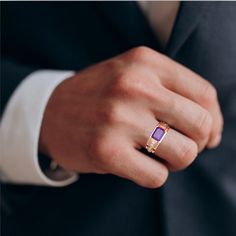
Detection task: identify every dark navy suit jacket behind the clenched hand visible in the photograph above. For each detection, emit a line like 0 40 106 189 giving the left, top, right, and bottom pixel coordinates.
1 2 236 236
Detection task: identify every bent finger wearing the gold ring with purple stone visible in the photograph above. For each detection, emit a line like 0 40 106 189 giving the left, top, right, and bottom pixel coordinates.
137 118 198 170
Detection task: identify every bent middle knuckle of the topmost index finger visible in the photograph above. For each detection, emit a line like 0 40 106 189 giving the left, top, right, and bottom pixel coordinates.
201 81 217 106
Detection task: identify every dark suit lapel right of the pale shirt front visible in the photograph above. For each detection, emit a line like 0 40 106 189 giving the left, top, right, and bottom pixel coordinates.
165 2 209 58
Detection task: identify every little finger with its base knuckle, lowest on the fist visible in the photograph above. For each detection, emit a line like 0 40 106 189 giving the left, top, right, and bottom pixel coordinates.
89 128 168 188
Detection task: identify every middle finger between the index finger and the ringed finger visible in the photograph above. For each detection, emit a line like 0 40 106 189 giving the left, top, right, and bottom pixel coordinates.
153 88 212 151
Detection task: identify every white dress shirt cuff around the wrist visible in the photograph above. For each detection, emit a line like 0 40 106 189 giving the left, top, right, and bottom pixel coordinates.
0 70 78 187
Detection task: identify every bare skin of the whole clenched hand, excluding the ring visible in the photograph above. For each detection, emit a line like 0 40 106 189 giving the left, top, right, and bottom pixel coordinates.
39 47 223 188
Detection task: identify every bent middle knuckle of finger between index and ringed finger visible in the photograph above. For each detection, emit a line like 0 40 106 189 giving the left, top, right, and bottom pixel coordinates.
196 111 212 140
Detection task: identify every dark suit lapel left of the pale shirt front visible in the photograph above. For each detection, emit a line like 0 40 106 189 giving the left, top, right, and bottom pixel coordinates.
95 1 159 50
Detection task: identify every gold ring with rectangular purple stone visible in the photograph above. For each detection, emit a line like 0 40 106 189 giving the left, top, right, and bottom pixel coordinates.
146 121 170 153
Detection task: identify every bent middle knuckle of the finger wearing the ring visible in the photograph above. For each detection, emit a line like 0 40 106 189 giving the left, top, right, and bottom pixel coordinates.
177 141 198 170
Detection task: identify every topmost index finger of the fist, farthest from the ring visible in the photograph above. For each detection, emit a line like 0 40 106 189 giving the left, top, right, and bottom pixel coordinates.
155 58 223 148
